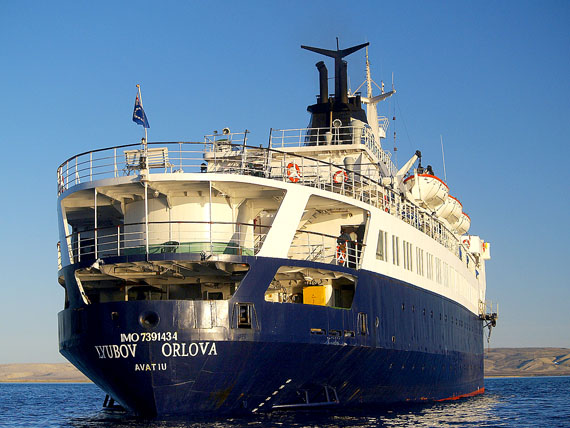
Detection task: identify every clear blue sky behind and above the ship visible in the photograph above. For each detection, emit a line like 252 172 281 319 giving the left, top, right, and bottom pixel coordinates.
0 1 570 363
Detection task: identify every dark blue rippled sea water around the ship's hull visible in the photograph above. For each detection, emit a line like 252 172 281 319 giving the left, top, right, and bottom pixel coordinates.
0 377 570 428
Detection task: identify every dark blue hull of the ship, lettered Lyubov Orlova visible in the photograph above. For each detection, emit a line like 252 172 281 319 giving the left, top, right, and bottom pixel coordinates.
59 255 483 415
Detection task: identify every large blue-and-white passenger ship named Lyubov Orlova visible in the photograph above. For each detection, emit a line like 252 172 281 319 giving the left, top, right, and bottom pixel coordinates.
57 43 497 417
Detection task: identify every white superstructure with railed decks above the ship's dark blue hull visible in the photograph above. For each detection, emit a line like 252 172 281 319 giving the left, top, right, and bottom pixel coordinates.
58 46 489 314
